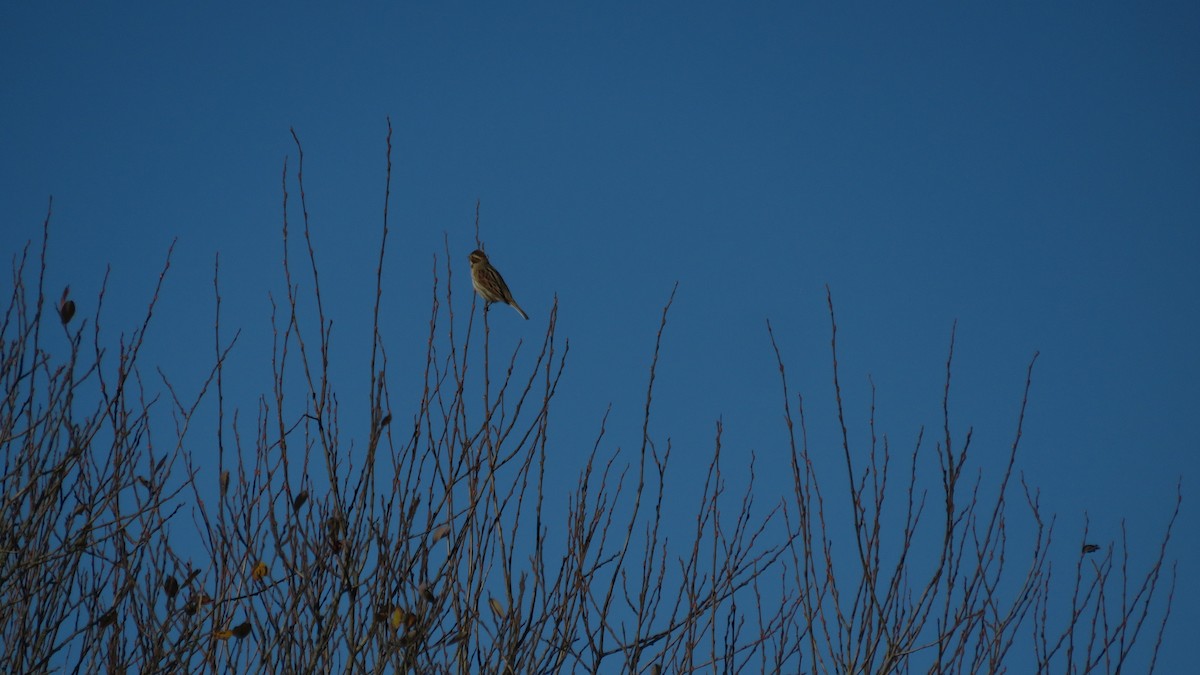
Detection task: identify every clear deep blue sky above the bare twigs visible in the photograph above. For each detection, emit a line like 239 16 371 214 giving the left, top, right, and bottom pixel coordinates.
0 2 1200 671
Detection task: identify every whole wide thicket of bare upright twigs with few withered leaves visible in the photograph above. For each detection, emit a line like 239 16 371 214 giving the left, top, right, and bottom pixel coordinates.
0 127 1177 673
